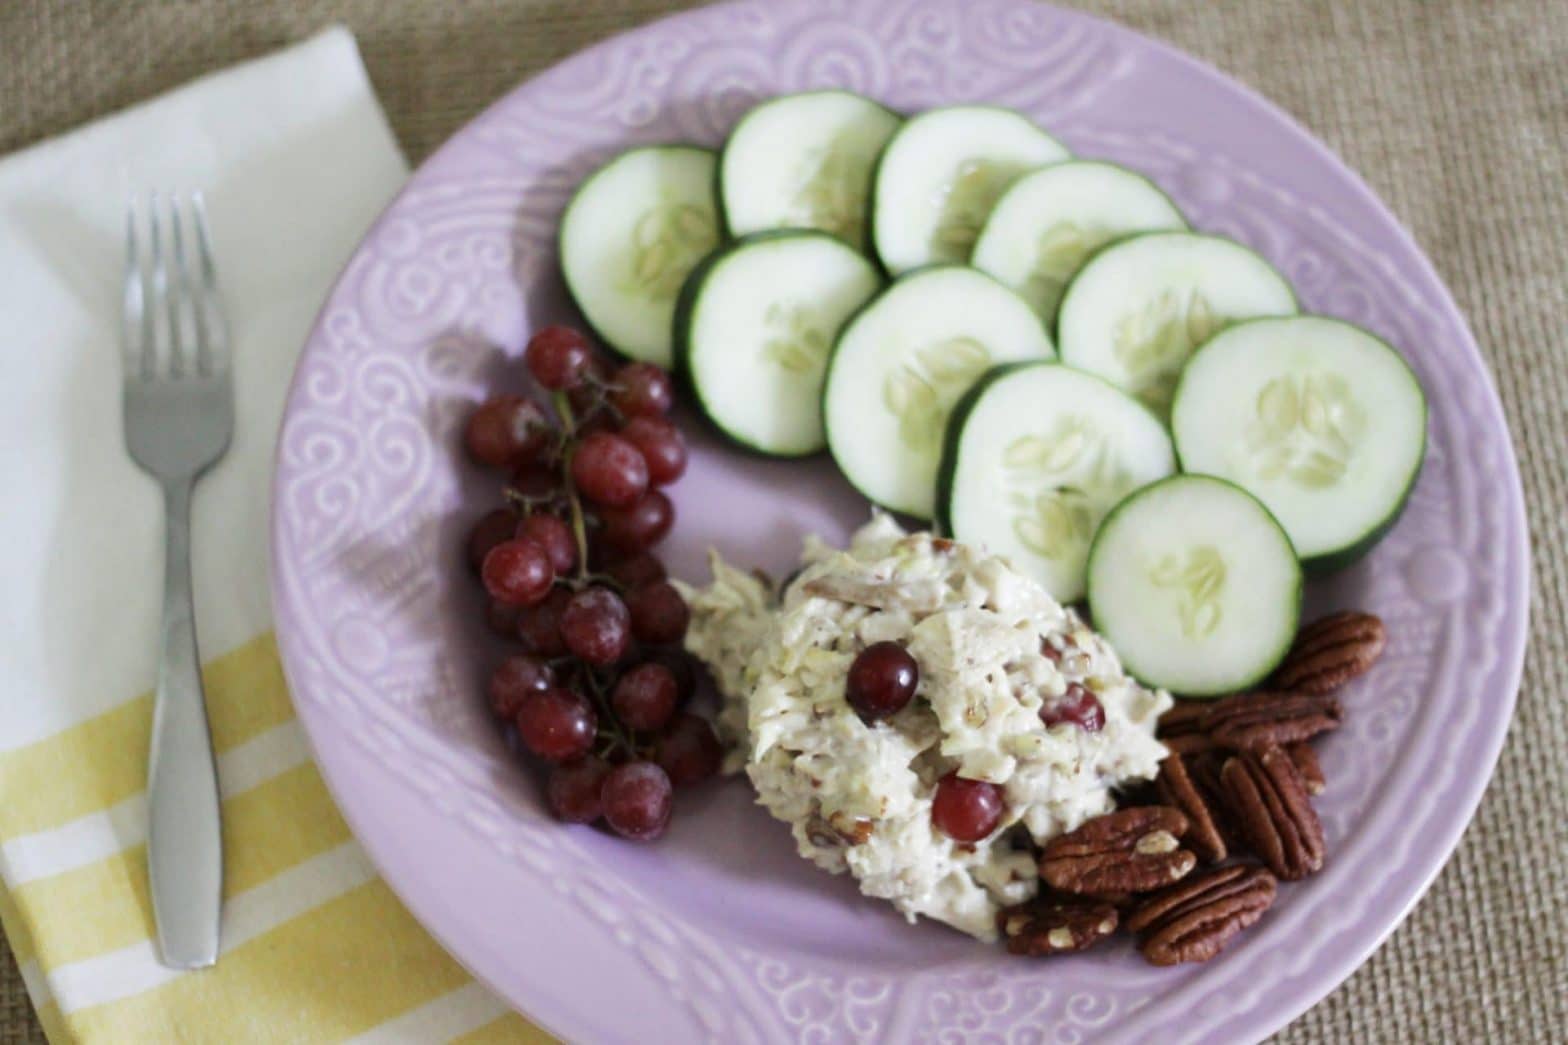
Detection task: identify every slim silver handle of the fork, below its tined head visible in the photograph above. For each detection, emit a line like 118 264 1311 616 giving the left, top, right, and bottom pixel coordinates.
147 480 223 968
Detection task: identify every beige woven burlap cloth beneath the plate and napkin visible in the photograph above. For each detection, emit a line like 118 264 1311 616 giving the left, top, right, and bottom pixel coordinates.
0 0 1568 1045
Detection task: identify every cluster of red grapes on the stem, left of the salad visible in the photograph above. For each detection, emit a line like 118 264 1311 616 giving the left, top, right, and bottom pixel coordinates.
464 326 721 841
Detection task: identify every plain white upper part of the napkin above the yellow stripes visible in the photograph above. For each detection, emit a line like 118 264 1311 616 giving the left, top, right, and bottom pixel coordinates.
0 28 408 740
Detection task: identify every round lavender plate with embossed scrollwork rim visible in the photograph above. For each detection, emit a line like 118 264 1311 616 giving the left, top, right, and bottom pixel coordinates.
273 0 1527 1043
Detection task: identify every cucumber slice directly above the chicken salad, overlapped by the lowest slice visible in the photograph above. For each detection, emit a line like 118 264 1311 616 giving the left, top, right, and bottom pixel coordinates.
936 362 1176 603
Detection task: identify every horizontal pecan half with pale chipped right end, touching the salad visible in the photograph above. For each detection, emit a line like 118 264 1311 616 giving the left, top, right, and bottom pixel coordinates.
1040 805 1198 896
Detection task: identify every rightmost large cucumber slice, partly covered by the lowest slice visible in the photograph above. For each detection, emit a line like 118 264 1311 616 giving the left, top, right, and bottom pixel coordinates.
1171 315 1427 570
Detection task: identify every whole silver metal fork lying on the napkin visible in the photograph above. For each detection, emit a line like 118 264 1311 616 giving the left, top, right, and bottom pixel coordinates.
122 193 234 968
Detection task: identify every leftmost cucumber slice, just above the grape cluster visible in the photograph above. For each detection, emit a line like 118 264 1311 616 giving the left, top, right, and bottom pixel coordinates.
560 146 718 369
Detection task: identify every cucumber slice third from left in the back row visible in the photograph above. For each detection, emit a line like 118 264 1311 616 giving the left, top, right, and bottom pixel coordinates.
872 105 1069 275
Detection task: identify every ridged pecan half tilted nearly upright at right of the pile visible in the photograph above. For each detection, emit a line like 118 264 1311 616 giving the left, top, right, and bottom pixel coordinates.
1220 747 1323 882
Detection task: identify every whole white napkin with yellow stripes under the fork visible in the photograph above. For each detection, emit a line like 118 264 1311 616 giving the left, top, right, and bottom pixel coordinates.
0 28 547 1045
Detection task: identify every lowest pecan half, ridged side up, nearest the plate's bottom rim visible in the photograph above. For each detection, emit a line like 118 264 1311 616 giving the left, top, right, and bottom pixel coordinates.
1126 865 1276 965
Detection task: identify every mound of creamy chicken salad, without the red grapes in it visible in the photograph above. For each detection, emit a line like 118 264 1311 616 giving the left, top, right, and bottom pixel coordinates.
682 515 1171 940
